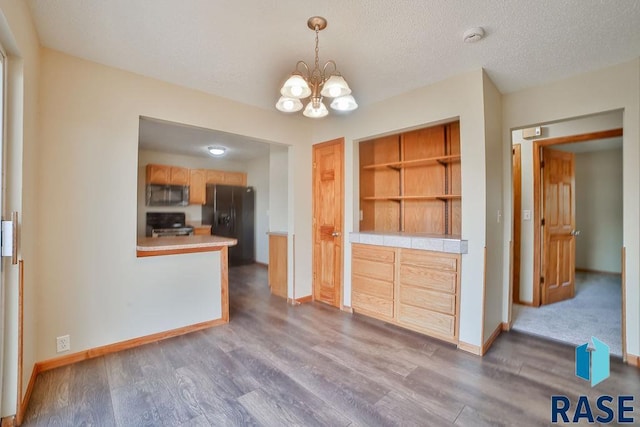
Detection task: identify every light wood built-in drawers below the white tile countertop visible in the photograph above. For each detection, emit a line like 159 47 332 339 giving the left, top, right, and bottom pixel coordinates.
351 244 460 343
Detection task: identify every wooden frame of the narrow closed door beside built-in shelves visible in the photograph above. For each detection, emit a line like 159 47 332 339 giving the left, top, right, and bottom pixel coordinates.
311 137 345 310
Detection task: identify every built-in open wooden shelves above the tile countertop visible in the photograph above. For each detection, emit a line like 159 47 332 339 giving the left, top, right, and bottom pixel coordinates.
360 122 462 235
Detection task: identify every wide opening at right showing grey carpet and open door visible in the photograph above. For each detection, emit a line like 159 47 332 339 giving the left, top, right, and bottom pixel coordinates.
512 111 624 356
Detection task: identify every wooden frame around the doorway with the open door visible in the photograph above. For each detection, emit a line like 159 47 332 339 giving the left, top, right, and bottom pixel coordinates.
532 128 624 306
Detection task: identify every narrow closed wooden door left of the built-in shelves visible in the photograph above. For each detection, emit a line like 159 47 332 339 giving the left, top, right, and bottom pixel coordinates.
313 138 344 307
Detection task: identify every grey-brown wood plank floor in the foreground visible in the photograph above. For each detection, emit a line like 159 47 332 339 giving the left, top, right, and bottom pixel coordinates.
23 266 640 426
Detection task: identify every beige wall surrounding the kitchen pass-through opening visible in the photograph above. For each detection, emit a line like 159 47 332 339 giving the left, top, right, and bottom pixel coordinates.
37 49 311 368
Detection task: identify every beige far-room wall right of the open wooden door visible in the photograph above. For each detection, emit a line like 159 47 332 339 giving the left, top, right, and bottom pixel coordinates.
575 149 623 273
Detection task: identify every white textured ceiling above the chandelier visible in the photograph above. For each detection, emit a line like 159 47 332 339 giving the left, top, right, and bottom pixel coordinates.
23 0 640 109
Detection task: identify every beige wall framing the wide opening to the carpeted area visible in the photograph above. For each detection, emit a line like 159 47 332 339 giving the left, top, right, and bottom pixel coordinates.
502 59 640 355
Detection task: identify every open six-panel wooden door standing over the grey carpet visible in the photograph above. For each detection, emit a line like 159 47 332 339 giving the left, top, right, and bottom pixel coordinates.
542 148 576 304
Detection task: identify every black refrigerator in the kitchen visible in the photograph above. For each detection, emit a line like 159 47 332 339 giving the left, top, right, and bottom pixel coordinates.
202 184 255 266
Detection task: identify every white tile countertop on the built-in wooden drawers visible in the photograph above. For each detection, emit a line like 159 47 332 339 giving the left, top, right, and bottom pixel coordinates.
349 231 469 254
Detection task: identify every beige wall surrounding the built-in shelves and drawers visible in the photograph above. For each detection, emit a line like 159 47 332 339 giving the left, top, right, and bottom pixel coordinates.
314 70 490 346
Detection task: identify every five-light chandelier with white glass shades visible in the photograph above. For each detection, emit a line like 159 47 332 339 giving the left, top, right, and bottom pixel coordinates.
276 16 358 118
